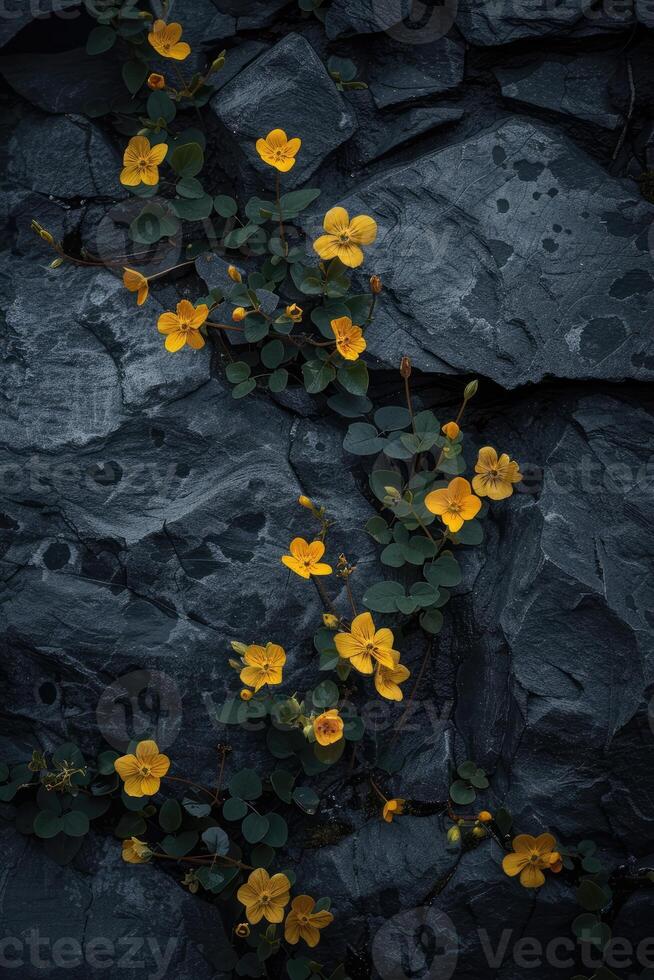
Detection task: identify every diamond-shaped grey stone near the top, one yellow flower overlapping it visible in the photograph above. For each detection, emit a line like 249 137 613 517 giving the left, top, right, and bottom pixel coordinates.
212 34 354 187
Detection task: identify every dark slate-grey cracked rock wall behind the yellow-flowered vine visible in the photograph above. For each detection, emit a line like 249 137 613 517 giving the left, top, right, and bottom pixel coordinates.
0 0 654 980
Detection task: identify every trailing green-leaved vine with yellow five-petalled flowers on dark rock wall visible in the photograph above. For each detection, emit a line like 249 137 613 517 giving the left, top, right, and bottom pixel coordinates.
16 0 654 980
